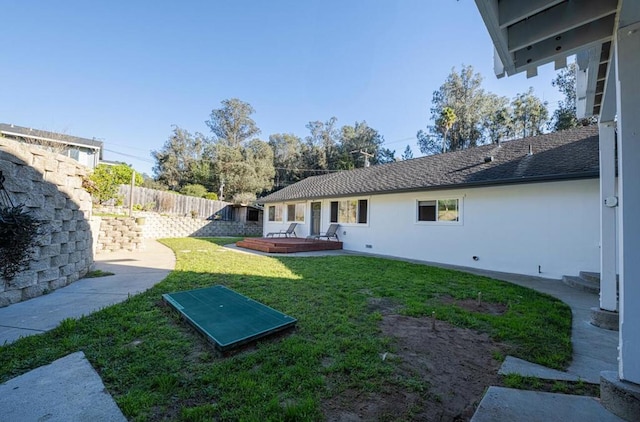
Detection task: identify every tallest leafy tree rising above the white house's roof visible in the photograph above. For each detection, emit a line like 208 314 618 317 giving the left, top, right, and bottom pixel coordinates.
417 65 488 154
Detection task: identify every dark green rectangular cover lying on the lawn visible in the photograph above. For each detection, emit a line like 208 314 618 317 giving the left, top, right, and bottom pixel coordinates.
162 286 297 351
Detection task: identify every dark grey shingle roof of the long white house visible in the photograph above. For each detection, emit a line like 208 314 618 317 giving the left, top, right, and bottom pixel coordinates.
258 126 599 203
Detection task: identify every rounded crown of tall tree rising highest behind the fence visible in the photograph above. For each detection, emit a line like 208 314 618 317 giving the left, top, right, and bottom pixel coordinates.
205 98 260 147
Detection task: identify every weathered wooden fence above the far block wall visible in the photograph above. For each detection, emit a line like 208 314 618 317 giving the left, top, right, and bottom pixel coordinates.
118 185 233 220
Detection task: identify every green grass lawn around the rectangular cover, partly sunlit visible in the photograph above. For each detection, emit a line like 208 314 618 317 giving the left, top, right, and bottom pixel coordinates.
0 238 571 421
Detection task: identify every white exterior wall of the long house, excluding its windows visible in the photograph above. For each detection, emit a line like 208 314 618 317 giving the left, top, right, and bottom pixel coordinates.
264 179 600 278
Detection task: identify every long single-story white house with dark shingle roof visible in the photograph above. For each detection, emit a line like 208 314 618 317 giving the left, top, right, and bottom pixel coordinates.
259 126 600 281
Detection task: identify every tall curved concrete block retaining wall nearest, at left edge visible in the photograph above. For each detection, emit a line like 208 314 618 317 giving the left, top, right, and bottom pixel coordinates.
0 137 93 307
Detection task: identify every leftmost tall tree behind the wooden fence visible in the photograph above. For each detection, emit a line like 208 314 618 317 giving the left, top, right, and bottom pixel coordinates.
151 125 213 191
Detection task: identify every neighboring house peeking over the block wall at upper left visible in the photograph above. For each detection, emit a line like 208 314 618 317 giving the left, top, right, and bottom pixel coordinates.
0 123 103 168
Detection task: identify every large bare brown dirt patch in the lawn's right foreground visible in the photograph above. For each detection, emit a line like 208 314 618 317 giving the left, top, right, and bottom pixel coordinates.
323 301 507 422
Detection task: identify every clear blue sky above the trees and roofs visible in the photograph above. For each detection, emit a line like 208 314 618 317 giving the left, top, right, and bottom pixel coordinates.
0 0 562 174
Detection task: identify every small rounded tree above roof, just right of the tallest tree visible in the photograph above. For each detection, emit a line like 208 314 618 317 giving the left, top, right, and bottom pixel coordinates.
511 88 549 138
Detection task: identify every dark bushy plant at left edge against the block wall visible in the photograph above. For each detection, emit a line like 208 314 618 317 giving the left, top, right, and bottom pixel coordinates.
0 205 42 280
